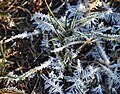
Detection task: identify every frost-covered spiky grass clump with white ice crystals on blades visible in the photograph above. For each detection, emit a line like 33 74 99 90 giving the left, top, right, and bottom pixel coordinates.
1 0 120 94
